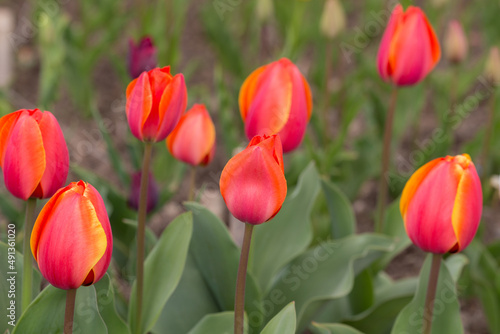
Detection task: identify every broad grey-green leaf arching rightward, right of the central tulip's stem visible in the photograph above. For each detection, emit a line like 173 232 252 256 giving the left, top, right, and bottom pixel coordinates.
264 234 393 330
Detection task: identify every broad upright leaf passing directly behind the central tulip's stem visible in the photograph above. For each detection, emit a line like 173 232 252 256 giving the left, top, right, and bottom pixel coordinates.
185 202 264 329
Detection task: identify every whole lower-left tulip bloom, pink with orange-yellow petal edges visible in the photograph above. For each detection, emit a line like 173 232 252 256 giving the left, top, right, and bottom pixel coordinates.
31 181 113 290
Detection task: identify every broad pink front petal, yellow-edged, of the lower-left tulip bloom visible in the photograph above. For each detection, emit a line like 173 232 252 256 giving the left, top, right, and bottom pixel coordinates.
32 190 107 290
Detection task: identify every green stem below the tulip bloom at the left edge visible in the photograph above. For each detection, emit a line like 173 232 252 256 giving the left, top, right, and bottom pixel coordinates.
21 198 36 313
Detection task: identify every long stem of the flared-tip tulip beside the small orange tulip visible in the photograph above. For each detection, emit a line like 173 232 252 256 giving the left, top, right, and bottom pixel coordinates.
135 142 153 334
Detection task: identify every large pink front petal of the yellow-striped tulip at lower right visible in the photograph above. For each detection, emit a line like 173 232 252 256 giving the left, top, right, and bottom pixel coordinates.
405 159 461 253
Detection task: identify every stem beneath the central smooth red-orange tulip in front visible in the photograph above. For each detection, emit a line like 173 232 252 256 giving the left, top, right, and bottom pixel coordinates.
234 223 253 334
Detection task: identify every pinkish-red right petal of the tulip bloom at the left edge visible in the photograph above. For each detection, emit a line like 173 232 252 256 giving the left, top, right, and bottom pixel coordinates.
37 111 69 198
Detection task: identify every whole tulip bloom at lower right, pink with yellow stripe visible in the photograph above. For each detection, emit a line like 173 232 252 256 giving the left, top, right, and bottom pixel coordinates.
400 154 483 254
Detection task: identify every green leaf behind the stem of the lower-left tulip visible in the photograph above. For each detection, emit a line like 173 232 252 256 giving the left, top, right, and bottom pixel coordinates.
12 285 108 334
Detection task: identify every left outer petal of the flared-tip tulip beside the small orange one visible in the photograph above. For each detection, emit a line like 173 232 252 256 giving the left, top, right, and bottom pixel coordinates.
126 72 153 140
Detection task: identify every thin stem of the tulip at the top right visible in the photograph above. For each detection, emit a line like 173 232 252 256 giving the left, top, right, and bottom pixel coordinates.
375 86 398 233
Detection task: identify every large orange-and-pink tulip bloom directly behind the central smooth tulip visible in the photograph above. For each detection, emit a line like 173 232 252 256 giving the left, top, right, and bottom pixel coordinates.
239 58 312 152
